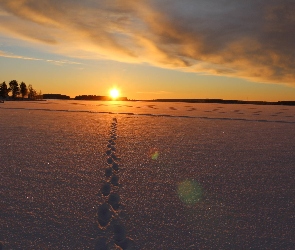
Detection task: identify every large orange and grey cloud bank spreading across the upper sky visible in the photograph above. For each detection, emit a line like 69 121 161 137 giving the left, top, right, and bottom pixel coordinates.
0 0 295 86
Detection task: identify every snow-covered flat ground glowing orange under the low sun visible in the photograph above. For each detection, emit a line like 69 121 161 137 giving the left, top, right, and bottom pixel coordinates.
0 100 295 250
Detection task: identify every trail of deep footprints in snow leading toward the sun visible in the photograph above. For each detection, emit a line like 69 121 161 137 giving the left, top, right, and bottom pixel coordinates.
95 118 136 250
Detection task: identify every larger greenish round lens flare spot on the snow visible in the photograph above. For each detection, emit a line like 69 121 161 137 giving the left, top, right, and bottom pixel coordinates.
177 180 202 205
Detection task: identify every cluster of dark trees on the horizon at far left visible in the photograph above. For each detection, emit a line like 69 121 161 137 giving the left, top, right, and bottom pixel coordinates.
0 80 41 99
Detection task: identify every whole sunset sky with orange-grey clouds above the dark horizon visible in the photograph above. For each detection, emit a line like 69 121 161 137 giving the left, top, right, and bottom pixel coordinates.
0 0 295 101
